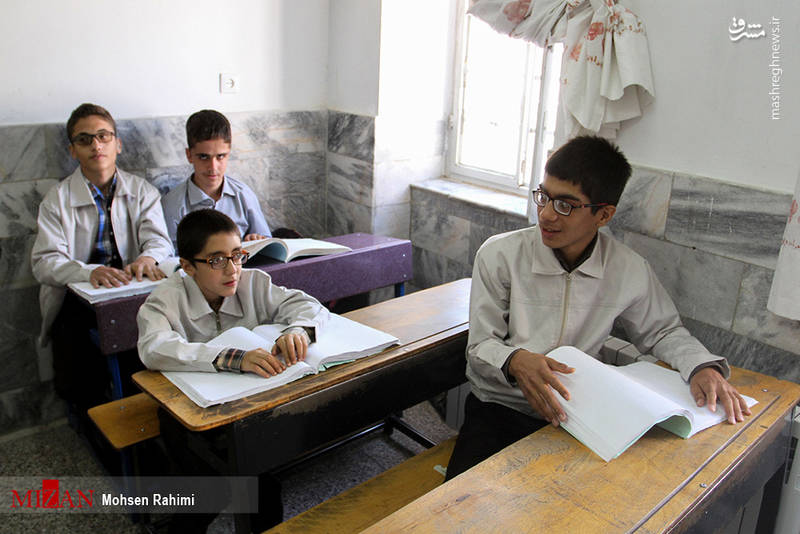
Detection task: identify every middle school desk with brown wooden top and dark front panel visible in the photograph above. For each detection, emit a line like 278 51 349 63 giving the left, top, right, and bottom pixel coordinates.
133 279 470 532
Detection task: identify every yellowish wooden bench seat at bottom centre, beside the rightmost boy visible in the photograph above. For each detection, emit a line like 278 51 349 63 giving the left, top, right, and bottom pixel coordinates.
267 438 455 534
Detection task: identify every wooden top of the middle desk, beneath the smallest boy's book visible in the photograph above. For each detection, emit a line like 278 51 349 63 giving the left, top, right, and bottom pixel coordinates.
133 278 470 431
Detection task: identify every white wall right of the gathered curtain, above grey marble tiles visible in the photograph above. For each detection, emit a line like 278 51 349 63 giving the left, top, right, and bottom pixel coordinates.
618 0 800 192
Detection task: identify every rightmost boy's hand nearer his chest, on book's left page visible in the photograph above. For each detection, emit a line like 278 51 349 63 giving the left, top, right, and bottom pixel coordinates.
508 349 575 426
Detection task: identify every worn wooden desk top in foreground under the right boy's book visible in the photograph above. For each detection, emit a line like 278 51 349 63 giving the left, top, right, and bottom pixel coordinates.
364 368 800 534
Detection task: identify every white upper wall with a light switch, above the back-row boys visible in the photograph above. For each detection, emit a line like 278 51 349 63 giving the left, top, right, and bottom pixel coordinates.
0 0 328 124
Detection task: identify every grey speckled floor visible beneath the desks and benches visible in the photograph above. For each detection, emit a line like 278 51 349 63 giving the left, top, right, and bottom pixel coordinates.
0 402 455 534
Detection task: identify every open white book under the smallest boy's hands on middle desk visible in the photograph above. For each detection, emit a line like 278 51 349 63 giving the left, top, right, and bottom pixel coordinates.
162 313 398 408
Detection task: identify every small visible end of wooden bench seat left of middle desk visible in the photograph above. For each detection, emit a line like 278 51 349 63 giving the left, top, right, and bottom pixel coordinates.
89 393 160 451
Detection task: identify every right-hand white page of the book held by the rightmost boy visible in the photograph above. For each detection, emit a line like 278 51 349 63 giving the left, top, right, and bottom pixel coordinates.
617 362 758 438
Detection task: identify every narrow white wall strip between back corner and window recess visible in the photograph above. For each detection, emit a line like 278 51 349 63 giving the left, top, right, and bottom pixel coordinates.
327 0 382 116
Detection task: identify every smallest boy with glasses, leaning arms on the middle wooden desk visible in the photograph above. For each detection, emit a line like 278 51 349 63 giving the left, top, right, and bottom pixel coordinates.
137 209 328 533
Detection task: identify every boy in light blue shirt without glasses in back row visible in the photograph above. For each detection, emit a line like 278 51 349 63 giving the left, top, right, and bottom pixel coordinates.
162 109 271 251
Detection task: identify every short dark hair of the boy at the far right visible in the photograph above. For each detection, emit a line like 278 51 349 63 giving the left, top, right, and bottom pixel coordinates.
544 135 631 209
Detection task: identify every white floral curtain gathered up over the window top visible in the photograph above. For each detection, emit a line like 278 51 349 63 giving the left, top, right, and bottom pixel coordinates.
468 0 655 140
